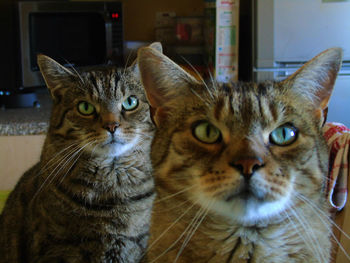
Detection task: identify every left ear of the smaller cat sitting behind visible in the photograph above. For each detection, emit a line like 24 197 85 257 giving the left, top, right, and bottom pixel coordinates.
37 54 76 99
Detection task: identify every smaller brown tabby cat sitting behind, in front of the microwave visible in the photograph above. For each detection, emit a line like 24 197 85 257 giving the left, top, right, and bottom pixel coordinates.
0 43 161 263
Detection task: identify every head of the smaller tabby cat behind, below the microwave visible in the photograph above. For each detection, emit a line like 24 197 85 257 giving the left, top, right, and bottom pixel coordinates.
39 56 153 158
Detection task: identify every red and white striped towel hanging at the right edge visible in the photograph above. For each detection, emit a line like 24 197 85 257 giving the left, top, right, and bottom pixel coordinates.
323 122 350 211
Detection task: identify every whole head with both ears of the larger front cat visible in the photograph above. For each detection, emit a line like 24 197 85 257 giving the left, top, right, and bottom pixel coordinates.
139 49 341 224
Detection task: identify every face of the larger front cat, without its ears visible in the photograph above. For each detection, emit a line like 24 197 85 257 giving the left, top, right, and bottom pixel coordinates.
154 83 327 222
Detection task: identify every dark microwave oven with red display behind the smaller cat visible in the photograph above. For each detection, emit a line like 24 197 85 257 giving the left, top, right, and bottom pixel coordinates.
0 0 124 105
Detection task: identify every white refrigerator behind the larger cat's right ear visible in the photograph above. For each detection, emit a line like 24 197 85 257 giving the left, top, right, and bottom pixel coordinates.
252 0 350 127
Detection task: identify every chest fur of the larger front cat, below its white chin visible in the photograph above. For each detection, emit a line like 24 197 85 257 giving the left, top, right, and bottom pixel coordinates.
148 194 330 263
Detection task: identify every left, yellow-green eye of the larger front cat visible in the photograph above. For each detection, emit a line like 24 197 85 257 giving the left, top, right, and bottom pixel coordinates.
193 121 221 144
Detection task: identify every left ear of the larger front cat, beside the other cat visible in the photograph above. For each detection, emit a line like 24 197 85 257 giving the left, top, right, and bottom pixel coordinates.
137 47 199 126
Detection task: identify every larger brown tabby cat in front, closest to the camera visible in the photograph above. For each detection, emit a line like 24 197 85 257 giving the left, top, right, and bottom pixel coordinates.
138 48 342 263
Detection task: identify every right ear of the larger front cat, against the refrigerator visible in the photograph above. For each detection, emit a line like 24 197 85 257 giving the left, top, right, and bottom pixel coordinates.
285 48 343 121
